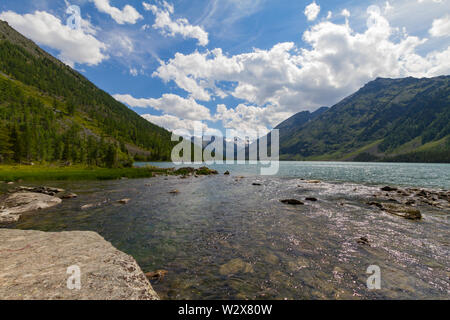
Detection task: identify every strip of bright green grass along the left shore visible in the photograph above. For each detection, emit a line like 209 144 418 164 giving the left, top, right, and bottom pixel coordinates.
0 165 171 182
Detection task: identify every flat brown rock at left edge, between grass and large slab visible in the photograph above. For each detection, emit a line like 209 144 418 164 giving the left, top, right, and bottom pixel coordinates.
0 192 62 223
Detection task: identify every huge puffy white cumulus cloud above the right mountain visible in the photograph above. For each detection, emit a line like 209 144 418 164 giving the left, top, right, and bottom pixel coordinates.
154 5 450 127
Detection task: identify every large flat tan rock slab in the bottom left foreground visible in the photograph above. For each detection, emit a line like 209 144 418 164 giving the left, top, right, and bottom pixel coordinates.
0 229 159 300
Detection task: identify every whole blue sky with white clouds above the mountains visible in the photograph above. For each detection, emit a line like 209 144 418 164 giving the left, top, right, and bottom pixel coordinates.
0 0 450 136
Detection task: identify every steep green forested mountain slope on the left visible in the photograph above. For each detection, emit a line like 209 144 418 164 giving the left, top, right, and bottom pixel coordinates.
0 21 174 166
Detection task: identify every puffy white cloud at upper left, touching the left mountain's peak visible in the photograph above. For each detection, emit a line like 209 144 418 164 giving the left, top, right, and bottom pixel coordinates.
0 11 108 67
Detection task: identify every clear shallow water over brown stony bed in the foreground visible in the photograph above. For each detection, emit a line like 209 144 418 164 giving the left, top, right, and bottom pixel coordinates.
1 164 450 299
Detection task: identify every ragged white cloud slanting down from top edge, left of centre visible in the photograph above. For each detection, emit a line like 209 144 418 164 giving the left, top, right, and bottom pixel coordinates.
142 1 209 46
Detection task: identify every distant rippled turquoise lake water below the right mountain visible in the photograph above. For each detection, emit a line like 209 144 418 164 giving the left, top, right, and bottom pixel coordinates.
137 161 450 190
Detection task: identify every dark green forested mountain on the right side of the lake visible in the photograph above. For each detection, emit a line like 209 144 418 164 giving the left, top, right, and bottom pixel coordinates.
277 76 450 162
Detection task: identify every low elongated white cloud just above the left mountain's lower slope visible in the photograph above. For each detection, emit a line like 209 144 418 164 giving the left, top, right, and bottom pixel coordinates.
113 94 211 120
